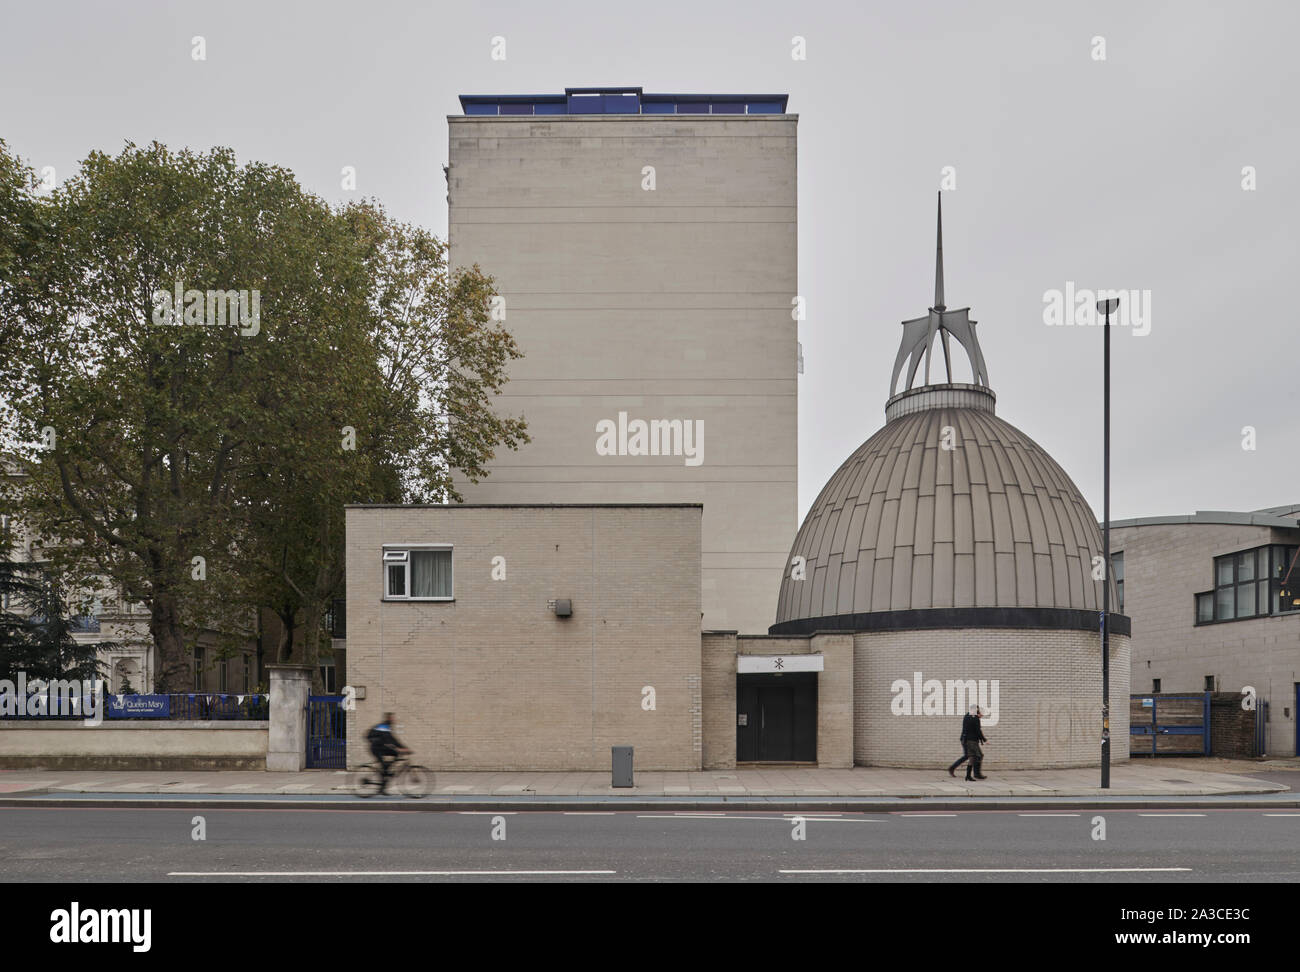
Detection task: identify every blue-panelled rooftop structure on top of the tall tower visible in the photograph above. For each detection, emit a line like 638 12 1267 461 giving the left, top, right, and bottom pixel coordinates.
460 88 789 116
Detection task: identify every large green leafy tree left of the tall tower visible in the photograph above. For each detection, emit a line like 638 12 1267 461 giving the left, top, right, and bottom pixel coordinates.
0 143 527 691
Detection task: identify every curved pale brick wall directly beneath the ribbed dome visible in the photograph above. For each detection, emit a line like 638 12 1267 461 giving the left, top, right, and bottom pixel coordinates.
854 628 1130 769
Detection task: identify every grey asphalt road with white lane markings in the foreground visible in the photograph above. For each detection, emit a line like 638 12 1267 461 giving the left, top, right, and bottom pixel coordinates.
0 807 1300 882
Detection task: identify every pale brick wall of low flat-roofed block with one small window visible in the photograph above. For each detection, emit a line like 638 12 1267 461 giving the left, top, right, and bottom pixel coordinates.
347 507 701 771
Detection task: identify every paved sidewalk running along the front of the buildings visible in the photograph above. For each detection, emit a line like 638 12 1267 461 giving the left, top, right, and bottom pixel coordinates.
0 759 1300 799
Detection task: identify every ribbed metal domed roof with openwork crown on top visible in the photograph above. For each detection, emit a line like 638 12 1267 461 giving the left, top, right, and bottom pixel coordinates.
771 197 1127 634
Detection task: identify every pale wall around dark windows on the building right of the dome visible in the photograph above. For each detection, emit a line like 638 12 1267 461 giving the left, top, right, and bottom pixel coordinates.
1110 524 1300 756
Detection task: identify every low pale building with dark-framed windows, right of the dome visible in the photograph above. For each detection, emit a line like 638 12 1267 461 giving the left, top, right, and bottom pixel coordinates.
1110 504 1300 756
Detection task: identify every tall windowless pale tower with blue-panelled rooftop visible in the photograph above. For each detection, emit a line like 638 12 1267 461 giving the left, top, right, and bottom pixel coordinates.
447 81 798 633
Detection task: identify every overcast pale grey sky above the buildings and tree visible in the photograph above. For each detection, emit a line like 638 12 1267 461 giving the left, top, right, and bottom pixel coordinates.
0 0 1300 518
